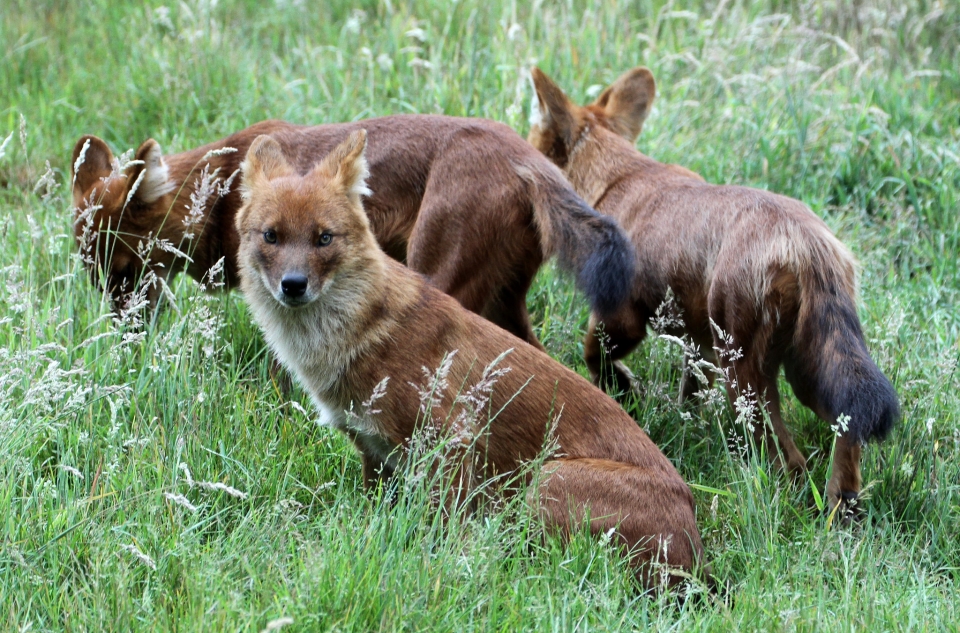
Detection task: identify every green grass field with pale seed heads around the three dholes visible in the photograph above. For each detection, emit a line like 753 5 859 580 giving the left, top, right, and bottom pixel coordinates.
0 0 960 631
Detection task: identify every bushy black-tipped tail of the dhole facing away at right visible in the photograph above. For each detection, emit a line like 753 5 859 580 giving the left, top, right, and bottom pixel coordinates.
786 274 900 444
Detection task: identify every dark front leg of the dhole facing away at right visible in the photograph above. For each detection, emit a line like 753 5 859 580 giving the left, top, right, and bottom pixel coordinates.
583 304 647 395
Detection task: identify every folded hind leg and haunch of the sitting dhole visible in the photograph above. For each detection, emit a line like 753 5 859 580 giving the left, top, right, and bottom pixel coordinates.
531 459 703 587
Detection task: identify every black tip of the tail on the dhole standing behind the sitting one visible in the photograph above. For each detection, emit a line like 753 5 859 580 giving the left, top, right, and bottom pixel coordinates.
577 216 636 316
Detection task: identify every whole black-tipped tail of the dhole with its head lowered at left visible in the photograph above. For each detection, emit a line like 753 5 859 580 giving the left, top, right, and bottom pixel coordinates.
518 164 636 316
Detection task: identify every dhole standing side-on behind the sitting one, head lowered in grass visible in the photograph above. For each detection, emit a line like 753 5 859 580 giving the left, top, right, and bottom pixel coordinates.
72 115 634 345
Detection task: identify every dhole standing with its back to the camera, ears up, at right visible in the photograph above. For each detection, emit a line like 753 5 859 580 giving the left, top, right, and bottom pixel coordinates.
529 68 899 519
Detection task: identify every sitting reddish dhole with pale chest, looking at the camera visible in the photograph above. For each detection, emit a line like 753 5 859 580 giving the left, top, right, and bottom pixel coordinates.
237 130 702 584
